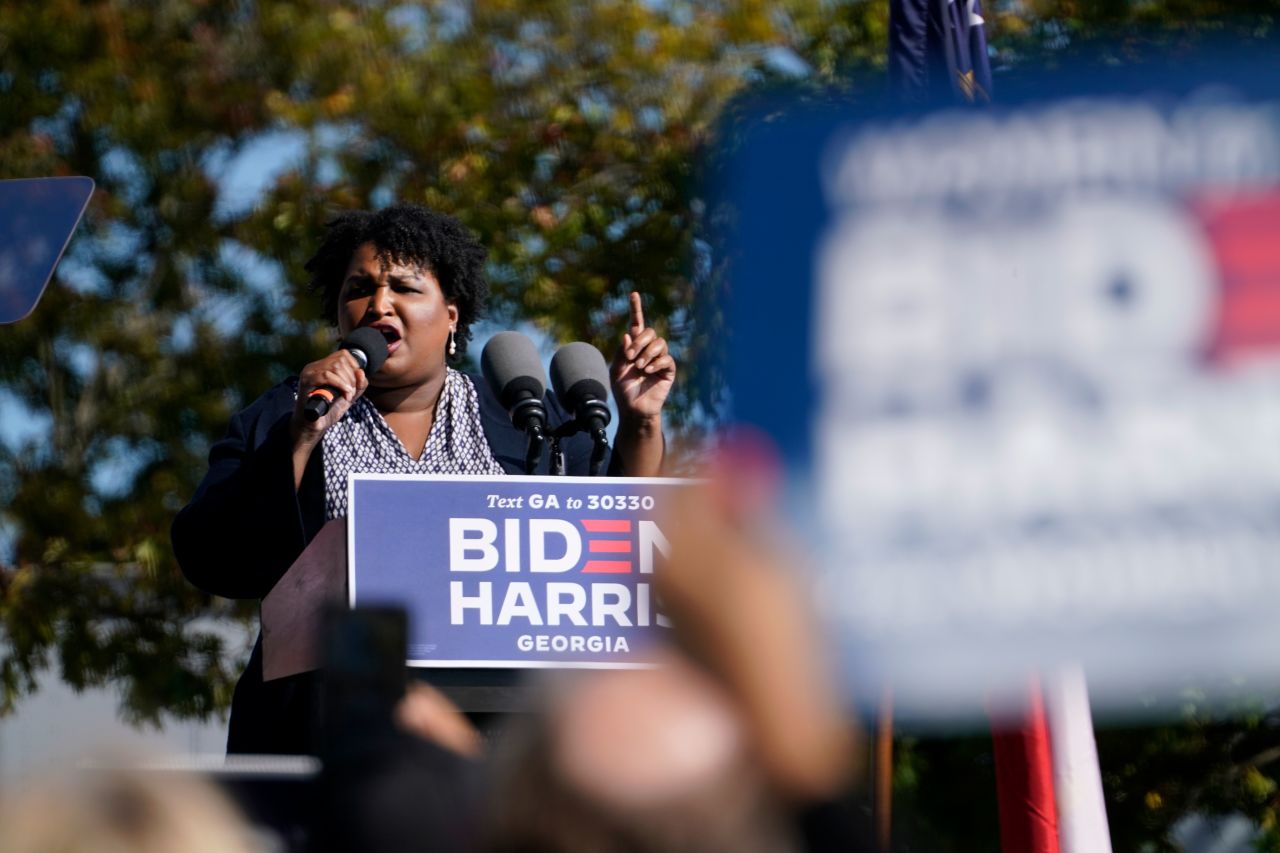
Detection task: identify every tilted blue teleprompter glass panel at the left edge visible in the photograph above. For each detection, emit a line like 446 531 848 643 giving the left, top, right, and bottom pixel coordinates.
0 178 93 324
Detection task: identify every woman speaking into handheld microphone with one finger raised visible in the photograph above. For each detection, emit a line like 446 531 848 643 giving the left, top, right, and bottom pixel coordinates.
173 205 676 753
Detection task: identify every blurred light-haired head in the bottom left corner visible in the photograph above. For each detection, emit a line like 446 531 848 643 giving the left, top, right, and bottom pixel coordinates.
0 768 261 853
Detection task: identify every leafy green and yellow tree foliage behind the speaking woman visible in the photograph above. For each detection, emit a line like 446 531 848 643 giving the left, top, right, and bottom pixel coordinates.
0 0 896 721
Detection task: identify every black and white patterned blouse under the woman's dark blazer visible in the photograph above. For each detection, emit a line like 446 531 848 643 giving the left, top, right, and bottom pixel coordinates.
314 368 506 520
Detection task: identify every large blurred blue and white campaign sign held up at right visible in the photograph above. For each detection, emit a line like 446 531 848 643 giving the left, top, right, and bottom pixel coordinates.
724 59 1280 715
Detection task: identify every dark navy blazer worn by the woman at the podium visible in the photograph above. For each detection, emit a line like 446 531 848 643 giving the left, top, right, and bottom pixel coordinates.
172 375 609 754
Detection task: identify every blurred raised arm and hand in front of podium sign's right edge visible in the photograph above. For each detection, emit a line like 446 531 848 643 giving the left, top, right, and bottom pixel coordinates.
654 434 859 802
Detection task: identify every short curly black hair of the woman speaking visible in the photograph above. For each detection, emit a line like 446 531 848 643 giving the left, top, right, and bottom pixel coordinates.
306 204 489 356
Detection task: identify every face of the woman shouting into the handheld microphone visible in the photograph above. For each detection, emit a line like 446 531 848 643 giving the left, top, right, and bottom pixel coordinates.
338 243 458 388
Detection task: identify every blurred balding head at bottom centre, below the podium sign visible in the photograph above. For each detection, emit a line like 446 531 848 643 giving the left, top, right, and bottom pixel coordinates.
492 645 794 853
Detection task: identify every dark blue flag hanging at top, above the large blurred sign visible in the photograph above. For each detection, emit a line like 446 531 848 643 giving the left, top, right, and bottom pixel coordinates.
888 0 992 104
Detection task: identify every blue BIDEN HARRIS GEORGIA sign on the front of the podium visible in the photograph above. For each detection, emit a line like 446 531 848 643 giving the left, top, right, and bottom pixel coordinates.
347 474 687 669
